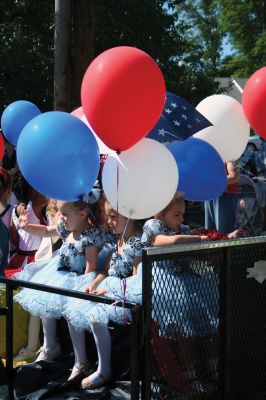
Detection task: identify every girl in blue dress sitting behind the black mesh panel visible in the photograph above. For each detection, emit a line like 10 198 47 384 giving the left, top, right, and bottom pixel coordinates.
142 193 214 391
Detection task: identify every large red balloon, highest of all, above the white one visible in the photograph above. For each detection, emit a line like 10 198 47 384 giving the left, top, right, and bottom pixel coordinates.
81 46 166 151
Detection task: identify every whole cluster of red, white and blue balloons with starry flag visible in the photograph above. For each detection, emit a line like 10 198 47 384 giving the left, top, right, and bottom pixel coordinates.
0 46 266 214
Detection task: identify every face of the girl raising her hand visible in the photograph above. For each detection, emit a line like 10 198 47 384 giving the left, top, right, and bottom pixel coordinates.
59 203 87 231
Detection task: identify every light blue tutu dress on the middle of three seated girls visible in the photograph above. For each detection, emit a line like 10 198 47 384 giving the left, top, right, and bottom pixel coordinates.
64 235 142 330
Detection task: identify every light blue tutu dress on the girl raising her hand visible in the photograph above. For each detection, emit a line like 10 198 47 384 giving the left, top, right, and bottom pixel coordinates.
14 220 104 318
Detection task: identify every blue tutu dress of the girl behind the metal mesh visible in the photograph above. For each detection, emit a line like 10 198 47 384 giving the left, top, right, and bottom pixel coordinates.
141 219 218 338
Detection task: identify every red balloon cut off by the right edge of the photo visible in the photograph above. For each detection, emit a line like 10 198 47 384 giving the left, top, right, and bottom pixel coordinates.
242 67 266 139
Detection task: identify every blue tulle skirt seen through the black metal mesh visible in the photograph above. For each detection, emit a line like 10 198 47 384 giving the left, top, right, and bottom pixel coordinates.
152 263 219 338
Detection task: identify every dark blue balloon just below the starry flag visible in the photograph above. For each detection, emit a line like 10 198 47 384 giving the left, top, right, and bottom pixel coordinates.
167 138 227 201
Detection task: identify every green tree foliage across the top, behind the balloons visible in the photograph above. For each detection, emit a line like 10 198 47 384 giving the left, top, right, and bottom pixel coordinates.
0 0 256 111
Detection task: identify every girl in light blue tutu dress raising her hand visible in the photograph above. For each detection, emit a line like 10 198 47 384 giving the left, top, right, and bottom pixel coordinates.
14 200 103 361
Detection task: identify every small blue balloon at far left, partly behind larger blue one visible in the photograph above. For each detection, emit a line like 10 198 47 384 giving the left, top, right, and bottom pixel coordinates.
1 100 41 146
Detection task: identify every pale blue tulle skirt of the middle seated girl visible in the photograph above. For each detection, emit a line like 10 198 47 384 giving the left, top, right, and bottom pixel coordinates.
64 264 142 330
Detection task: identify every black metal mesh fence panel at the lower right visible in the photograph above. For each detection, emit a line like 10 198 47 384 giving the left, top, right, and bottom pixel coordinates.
142 237 266 400
